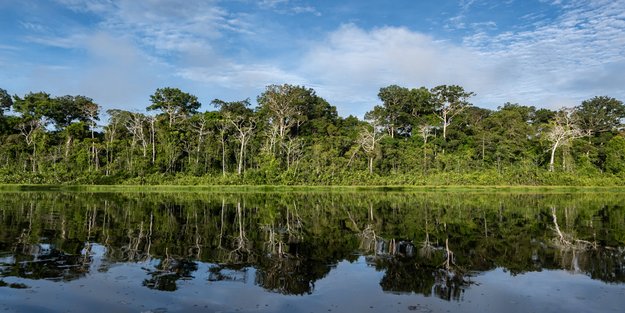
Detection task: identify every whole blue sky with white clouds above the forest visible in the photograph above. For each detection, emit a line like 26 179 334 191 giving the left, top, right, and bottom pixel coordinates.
0 0 625 117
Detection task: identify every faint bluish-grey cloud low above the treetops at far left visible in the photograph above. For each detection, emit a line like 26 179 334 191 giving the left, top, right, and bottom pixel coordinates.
22 32 163 110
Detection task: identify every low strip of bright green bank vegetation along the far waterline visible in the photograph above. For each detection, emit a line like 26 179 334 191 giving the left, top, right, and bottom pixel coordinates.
0 169 625 190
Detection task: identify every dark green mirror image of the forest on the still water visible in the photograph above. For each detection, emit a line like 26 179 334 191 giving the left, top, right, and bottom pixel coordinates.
0 192 625 299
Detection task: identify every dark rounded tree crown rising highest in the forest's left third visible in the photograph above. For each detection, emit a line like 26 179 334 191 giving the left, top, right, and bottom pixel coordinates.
147 87 201 127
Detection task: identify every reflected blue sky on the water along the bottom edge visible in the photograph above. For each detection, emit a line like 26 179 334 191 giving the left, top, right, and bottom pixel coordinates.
0 255 625 313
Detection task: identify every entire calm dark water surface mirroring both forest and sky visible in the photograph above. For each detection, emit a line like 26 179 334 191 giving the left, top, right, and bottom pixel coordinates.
0 192 625 312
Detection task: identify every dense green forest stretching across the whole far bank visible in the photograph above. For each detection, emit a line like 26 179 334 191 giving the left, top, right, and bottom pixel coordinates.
0 84 625 185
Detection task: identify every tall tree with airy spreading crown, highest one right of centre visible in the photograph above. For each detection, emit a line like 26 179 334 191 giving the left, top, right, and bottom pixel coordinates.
430 85 475 140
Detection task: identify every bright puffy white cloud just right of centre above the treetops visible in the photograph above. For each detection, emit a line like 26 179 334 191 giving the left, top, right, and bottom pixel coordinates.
298 25 508 115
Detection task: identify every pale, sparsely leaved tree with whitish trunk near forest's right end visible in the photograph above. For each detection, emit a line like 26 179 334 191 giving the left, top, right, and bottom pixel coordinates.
547 108 584 172
